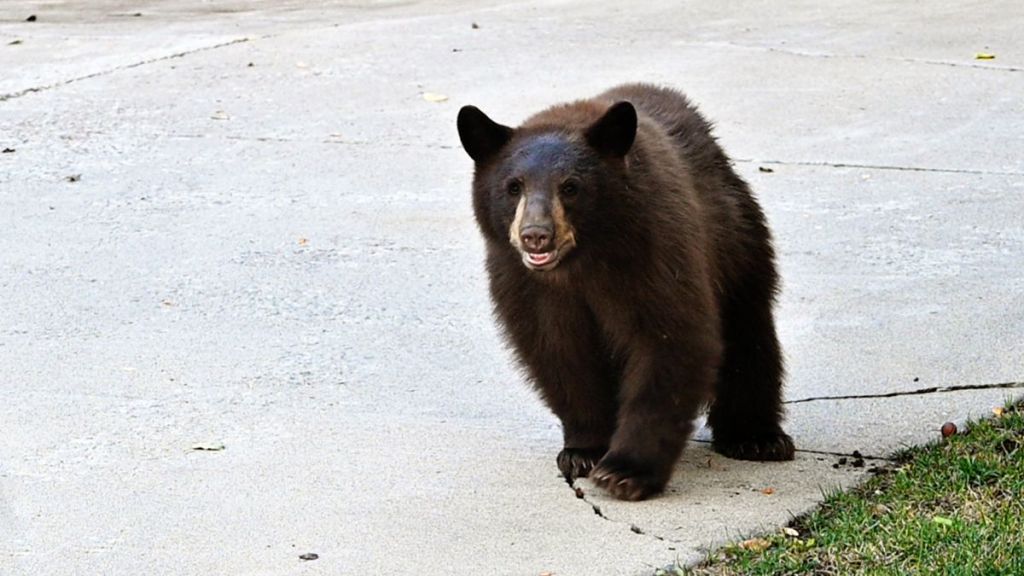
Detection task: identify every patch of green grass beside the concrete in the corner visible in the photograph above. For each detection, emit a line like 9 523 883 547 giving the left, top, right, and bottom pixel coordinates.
658 404 1024 576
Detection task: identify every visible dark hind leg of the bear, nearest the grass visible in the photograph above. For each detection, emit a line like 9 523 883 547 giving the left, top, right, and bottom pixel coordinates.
708 283 794 460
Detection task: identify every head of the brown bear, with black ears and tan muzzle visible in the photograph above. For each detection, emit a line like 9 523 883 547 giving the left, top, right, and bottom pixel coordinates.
458 101 637 272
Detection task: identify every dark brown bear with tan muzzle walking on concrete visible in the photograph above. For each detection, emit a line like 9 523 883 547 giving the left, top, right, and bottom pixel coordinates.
457 84 795 500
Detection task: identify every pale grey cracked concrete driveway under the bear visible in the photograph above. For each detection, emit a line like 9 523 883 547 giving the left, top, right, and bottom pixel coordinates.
0 0 1024 576
